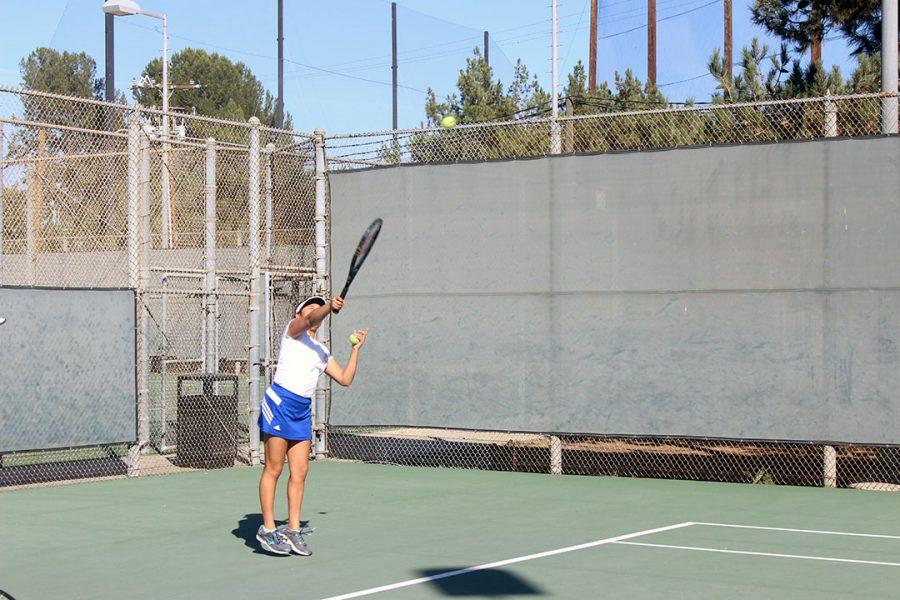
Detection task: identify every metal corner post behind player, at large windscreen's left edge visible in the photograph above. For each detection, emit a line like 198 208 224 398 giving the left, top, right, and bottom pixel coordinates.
314 128 331 458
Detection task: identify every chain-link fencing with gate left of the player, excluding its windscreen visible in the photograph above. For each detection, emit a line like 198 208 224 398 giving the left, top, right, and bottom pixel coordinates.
0 88 316 486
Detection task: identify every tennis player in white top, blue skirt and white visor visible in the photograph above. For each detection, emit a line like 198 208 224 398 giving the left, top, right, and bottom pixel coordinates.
256 296 368 556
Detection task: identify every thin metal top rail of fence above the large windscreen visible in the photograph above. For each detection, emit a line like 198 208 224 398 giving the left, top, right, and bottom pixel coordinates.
325 92 900 140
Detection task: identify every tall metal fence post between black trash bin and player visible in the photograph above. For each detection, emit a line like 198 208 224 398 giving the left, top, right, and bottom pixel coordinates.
247 117 260 465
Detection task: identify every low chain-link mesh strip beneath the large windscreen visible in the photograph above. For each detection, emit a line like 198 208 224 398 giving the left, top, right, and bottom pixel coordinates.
328 426 900 491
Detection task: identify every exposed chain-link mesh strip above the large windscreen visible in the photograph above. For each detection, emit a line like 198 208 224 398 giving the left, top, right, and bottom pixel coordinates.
328 94 897 169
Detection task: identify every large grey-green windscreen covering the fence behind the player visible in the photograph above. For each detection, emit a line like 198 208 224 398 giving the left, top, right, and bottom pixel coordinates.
330 137 900 443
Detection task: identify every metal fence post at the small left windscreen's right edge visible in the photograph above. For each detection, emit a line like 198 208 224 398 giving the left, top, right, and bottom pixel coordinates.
125 110 143 477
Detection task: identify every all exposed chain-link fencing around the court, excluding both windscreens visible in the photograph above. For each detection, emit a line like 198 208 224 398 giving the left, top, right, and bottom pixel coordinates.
0 88 900 490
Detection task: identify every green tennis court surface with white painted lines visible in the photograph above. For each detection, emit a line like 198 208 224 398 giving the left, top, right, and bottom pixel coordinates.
0 461 900 600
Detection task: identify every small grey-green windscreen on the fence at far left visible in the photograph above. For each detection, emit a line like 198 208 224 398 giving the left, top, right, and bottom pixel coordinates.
0 287 136 453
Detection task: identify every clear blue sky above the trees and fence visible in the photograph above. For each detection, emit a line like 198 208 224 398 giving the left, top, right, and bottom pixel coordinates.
0 0 854 133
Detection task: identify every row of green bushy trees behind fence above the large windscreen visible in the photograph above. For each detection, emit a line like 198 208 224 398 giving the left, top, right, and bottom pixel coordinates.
404 39 879 162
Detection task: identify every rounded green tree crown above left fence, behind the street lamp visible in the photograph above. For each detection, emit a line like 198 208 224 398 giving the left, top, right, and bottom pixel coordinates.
134 48 291 129
